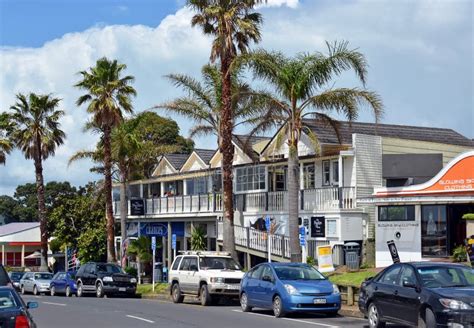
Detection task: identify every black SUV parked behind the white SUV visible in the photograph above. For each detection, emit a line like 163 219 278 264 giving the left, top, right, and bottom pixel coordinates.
76 262 137 298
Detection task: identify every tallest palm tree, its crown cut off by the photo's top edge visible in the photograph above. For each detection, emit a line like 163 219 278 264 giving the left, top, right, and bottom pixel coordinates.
188 0 262 256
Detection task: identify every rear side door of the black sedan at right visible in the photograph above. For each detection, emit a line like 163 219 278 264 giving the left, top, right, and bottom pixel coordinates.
373 264 402 318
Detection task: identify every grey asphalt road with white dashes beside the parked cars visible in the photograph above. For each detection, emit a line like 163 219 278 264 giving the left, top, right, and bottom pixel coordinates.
19 296 404 328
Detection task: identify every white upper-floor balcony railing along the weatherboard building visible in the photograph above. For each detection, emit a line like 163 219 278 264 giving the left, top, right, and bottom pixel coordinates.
114 187 356 216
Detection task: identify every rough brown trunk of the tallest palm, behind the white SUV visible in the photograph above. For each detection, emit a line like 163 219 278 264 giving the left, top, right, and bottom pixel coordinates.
219 55 237 259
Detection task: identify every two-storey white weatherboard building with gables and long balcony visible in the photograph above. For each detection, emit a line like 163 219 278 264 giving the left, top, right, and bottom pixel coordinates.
114 121 474 266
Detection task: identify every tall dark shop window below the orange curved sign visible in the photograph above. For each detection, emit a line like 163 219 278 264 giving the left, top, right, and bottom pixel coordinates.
421 205 448 256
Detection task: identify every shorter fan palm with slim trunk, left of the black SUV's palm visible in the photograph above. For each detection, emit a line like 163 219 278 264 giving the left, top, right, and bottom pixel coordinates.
10 93 66 270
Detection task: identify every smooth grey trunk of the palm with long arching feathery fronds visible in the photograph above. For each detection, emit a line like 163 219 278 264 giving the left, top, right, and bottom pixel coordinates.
288 140 301 262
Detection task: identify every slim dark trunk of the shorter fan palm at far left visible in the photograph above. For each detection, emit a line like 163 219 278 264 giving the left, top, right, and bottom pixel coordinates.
35 152 48 271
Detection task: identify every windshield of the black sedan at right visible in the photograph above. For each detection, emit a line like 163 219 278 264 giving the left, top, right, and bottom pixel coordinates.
418 266 474 288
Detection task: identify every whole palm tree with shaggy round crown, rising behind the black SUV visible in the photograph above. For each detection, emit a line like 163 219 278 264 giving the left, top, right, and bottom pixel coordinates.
75 58 136 262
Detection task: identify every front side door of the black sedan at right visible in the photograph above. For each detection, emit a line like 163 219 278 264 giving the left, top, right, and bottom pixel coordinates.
393 265 420 325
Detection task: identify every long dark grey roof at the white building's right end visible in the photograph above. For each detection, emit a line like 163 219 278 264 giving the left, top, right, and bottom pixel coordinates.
304 120 474 147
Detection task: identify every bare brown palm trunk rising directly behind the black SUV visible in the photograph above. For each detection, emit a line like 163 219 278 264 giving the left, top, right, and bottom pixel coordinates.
104 125 117 262
